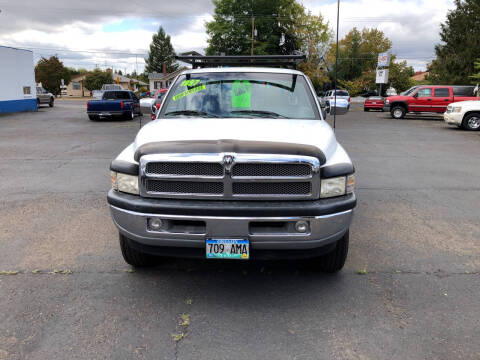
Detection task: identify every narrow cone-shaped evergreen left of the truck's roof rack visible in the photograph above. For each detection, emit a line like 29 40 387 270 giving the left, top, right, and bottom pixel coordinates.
145 26 178 73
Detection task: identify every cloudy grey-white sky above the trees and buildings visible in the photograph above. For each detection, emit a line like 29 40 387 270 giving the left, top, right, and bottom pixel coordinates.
0 0 454 72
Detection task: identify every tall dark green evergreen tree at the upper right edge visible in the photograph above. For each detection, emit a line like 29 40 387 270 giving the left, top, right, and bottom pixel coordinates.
428 0 480 85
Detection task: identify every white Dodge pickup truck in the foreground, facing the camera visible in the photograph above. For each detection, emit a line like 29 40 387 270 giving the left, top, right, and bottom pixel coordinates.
108 59 356 272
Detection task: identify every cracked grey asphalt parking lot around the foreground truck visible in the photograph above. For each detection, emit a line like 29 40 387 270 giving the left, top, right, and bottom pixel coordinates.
0 101 480 360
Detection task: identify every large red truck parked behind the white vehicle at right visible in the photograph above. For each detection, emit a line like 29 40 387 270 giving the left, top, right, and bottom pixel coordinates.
383 85 477 119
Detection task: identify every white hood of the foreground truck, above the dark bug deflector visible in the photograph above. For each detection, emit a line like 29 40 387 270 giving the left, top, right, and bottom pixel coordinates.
133 118 337 159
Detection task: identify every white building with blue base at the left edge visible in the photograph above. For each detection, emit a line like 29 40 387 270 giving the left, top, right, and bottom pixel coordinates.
0 46 37 113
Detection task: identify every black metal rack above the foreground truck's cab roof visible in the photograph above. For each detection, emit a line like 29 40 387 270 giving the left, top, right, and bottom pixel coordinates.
175 54 307 69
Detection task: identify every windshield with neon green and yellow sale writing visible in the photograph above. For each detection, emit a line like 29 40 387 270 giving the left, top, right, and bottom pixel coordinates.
159 72 319 119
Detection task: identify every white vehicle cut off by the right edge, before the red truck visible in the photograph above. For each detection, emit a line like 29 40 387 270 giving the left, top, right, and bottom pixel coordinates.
443 100 480 131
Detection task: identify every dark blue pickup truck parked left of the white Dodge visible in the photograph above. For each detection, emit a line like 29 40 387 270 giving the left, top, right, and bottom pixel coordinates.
87 90 142 120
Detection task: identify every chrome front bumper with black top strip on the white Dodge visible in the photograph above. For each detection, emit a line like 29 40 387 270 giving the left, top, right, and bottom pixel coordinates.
108 190 356 257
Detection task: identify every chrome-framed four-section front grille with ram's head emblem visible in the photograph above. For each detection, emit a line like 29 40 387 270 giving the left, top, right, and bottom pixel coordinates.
140 154 320 200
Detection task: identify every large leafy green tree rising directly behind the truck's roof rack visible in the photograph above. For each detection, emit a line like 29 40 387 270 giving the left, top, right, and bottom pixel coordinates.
206 0 304 55
